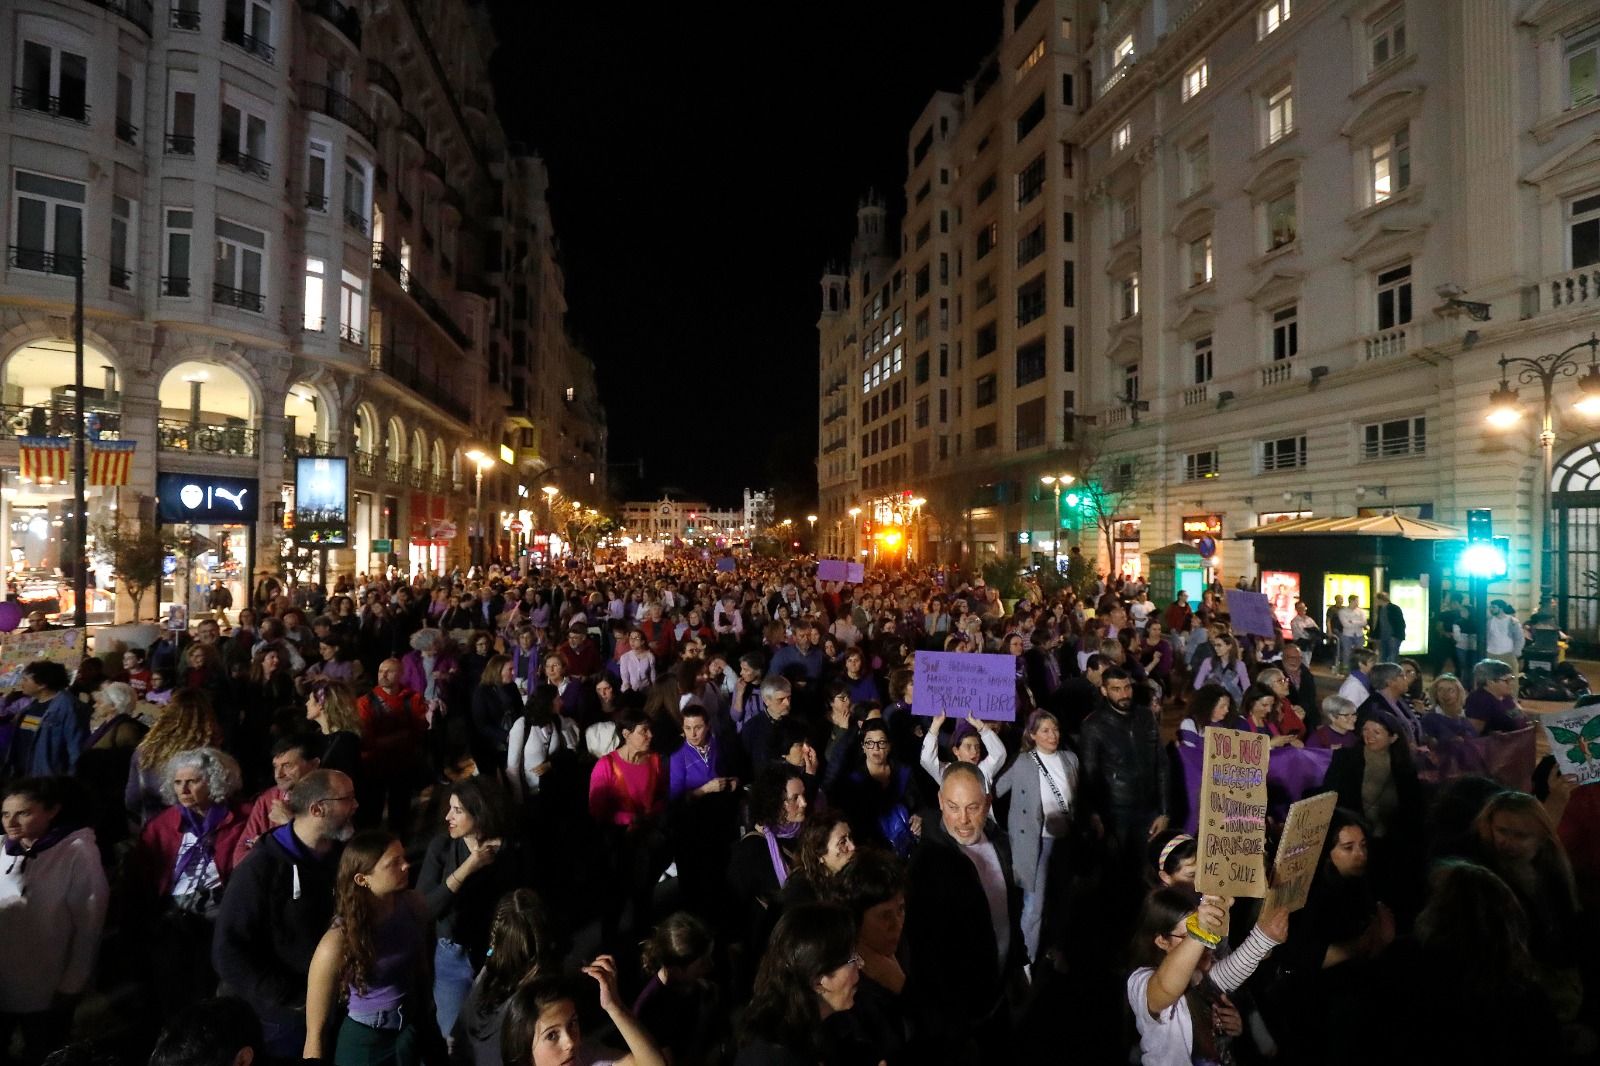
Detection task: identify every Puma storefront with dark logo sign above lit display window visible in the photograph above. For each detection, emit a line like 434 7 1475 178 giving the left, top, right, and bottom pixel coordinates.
155 472 261 619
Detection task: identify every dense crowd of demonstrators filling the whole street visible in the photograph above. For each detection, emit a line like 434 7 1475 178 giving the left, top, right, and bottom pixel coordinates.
0 554 1600 1066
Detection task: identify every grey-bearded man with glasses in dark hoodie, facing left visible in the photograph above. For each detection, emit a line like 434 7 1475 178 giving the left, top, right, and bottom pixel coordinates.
211 770 355 1060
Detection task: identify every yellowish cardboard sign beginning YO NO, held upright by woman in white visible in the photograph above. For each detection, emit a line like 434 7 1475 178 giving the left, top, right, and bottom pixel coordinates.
1196 726 1270 898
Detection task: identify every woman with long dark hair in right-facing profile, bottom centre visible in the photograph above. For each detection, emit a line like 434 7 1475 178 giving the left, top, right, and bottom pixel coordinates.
734 903 864 1066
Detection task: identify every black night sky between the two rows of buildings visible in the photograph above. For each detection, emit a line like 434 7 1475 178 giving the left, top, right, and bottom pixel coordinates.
491 0 1000 509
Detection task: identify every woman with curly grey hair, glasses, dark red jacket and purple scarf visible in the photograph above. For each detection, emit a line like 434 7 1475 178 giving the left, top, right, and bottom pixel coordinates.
130 747 248 1016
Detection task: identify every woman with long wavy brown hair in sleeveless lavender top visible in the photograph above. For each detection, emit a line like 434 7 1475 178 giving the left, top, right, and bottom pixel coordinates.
304 829 430 1066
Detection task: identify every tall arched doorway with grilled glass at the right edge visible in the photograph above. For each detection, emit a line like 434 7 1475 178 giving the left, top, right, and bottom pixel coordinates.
1550 440 1600 656
